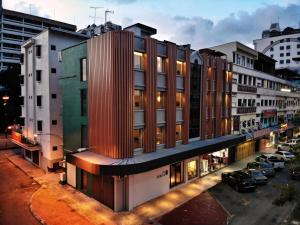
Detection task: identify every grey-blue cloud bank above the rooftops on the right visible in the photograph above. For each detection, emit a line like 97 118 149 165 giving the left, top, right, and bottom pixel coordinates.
170 3 300 49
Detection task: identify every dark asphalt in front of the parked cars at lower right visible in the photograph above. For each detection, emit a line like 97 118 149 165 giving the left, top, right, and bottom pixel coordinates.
209 165 300 225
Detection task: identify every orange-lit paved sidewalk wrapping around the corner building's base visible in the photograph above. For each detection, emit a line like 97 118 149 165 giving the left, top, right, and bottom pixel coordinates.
9 149 255 225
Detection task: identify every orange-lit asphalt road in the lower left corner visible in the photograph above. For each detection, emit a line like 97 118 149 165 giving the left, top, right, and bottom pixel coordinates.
0 150 40 225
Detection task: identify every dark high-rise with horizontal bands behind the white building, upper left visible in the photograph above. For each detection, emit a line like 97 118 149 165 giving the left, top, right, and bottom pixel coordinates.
0 0 76 70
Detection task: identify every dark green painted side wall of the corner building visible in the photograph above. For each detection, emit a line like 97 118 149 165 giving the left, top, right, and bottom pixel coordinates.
59 42 87 151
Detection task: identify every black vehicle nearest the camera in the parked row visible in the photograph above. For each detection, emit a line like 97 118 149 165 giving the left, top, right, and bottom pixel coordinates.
222 170 256 191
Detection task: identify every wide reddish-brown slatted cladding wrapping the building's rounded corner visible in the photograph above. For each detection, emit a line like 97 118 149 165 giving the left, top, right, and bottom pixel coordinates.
88 31 134 158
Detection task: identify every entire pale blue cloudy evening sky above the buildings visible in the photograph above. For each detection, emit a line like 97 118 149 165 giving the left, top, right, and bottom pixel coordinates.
3 0 300 49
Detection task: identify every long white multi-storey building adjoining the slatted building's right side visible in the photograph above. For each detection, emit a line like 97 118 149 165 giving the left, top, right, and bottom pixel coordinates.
212 42 300 156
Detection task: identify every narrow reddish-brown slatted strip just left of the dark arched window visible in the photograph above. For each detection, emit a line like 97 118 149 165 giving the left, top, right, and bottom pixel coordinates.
182 48 191 144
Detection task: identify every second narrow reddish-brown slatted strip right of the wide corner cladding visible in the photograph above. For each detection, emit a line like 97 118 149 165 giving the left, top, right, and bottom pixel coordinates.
166 42 177 148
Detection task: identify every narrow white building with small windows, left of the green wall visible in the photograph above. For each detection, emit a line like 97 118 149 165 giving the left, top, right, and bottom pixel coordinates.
20 28 86 171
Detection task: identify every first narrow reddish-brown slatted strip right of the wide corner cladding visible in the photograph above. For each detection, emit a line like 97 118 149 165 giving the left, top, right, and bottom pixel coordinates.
144 37 157 152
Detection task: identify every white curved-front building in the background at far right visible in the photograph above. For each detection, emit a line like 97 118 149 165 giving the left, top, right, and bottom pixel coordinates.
253 23 300 70
